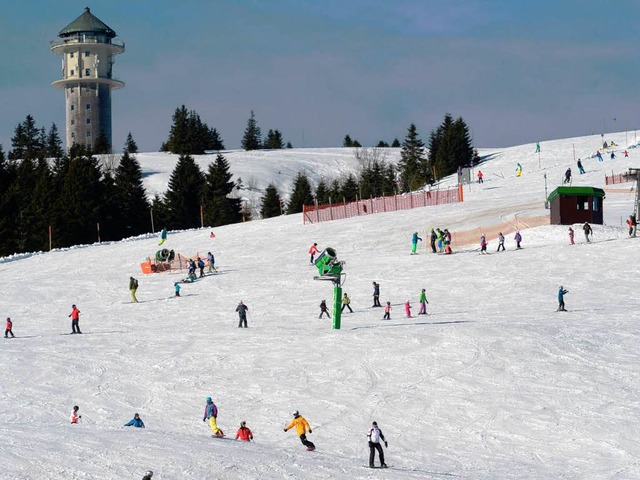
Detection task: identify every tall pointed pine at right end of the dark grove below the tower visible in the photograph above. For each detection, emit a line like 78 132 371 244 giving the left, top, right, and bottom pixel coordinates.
114 149 151 238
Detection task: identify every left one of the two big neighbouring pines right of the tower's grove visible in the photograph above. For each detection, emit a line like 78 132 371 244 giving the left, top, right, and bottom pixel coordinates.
164 155 204 230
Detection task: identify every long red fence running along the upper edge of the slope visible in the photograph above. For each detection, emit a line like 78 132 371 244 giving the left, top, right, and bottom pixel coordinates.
302 185 463 224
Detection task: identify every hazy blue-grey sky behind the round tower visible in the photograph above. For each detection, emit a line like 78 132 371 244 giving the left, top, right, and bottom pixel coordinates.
0 0 640 151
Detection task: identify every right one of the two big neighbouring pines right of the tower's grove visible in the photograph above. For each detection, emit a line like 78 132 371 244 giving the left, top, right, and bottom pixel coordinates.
204 154 246 227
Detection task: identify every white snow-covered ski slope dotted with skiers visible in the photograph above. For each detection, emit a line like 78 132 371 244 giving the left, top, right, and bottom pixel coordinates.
0 133 640 480
